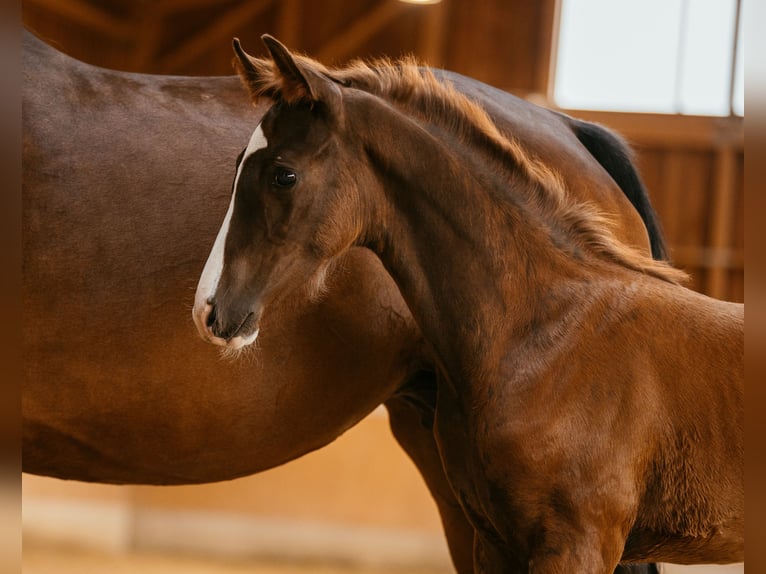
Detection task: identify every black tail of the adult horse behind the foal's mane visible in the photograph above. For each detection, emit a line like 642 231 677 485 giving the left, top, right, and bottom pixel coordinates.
572 119 669 261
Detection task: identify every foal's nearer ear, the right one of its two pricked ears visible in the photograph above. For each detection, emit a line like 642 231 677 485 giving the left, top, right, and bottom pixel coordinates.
261 34 341 112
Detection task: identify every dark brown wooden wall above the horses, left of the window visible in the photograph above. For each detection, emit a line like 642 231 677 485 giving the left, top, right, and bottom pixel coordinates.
22 0 555 91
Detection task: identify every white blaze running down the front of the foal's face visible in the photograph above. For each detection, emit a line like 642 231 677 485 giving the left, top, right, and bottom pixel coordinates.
192 124 268 346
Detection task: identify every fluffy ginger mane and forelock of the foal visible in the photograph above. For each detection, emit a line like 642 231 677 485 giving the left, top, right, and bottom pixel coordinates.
234 49 687 283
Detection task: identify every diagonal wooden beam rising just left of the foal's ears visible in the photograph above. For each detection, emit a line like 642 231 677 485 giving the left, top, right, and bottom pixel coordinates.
160 0 274 73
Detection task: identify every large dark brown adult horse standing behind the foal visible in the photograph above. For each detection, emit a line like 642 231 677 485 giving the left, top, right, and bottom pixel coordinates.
22 33 659 572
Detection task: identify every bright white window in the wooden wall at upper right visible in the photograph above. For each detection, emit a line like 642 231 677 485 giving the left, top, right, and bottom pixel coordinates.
554 0 746 116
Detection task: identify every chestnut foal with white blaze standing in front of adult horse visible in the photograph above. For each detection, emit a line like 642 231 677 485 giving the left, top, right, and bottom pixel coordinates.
194 37 744 573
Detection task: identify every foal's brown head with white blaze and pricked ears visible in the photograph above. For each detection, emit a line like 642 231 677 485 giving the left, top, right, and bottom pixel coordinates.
193 36 364 349
